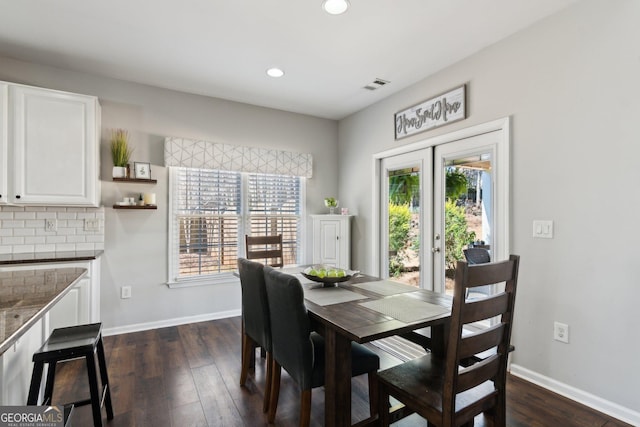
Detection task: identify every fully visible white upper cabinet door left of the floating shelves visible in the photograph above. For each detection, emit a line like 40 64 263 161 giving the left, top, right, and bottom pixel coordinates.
9 86 100 206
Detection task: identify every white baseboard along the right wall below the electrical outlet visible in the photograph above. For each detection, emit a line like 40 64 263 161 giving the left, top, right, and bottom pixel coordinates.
510 364 640 426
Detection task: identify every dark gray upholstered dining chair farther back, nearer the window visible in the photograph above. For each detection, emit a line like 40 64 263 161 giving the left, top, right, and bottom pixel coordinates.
238 258 273 412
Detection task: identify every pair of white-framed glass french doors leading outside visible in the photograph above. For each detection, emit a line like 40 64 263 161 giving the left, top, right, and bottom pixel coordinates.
378 121 509 292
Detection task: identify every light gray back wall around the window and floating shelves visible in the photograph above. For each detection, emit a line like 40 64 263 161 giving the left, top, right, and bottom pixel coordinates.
0 58 338 332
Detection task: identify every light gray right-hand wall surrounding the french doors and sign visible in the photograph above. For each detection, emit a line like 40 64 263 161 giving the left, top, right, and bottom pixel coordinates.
339 0 640 425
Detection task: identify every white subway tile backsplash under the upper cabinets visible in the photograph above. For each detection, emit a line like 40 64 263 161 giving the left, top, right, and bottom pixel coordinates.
0 206 105 254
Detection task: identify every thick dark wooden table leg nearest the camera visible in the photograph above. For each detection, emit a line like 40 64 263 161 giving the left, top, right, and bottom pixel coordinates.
324 328 351 427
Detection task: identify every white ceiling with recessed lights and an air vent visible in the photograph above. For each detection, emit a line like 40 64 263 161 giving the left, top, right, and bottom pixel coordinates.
0 0 578 119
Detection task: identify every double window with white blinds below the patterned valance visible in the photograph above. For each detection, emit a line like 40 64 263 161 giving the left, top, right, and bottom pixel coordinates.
168 167 304 283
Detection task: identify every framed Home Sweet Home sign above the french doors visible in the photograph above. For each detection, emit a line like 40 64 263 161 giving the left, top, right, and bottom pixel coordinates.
395 85 467 139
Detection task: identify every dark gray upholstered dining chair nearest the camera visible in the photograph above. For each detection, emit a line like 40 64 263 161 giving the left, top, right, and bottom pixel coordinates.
264 267 380 426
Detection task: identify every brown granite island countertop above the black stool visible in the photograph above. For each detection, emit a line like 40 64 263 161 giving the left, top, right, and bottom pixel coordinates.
0 268 87 355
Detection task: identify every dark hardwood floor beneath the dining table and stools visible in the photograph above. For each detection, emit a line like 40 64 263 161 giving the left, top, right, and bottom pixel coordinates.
48 318 628 427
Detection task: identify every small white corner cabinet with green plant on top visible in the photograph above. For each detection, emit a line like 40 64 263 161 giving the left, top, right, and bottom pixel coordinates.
311 215 352 269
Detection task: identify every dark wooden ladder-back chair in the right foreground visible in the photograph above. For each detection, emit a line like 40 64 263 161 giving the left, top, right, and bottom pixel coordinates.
378 255 520 427
